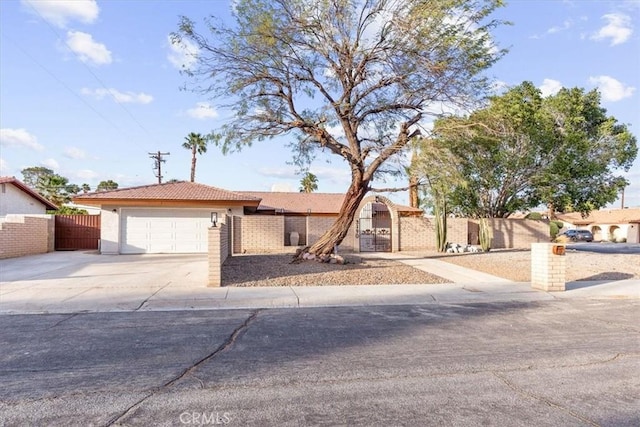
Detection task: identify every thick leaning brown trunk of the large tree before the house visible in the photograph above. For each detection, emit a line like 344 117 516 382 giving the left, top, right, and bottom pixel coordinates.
308 179 369 256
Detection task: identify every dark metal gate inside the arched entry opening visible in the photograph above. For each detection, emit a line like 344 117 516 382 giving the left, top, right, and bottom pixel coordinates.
358 203 391 252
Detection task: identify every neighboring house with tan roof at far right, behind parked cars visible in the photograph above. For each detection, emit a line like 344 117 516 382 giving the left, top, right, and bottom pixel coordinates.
557 208 640 243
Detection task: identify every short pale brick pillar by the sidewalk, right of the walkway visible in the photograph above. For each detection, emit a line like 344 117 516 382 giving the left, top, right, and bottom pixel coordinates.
531 243 566 292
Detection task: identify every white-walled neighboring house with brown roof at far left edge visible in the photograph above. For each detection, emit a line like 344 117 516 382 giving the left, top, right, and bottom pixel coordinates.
0 176 58 217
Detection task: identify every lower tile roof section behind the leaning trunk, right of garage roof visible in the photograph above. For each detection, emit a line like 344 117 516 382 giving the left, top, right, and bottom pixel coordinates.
239 191 422 215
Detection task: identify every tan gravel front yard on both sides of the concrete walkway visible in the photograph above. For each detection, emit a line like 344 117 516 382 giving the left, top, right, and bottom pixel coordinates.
222 250 640 286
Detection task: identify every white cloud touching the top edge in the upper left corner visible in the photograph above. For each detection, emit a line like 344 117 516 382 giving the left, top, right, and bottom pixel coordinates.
22 0 100 28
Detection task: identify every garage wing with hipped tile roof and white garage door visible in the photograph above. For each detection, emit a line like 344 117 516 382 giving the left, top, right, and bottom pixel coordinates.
73 182 260 254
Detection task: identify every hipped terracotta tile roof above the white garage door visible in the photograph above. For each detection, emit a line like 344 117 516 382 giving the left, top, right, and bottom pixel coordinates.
73 181 259 204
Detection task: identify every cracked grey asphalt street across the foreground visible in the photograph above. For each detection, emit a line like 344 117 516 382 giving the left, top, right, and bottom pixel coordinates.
0 299 640 426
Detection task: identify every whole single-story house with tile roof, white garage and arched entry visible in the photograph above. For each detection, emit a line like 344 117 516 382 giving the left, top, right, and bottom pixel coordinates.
73 182 422 254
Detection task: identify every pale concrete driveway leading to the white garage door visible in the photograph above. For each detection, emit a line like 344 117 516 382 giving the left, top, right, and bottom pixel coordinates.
0 251 212 313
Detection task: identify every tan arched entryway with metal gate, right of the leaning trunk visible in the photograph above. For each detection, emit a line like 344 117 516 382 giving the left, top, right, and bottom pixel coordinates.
356 196 397 252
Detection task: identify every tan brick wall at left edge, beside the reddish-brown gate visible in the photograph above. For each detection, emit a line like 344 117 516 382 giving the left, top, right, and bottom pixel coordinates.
0 215 55 259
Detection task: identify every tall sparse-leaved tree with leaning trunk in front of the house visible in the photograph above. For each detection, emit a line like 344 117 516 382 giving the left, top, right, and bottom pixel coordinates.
172 0 504 254
